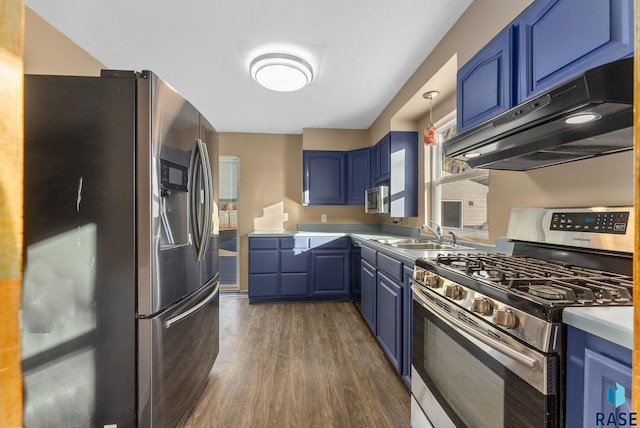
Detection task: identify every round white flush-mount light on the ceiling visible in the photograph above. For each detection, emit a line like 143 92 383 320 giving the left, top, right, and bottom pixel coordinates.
249 53 313 92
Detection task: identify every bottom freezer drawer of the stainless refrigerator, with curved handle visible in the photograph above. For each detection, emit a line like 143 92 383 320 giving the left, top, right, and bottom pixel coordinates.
138 276 220 428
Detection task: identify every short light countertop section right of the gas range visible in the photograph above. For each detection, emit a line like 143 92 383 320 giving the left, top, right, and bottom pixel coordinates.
562 306 633 349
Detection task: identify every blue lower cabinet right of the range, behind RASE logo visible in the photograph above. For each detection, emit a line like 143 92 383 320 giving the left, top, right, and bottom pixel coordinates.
565 326 640 427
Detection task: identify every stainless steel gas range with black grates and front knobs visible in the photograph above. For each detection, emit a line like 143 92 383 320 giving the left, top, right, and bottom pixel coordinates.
411 207 634 428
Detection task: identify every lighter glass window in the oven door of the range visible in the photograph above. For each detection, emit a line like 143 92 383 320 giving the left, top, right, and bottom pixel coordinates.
424 319 505 428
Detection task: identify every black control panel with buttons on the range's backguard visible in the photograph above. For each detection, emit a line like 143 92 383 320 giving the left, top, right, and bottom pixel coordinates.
550 211 629 235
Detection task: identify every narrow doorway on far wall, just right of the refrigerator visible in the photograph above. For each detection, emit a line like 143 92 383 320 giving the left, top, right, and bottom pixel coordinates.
219 156 240 291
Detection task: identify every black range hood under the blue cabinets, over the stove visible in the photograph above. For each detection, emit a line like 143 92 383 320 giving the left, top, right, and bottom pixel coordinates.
443 58 633 171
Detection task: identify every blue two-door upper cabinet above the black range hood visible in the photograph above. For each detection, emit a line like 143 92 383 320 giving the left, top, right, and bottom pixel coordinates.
456 0 634 133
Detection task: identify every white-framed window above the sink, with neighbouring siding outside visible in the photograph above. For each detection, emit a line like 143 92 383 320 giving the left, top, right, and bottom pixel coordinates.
431 120 489 239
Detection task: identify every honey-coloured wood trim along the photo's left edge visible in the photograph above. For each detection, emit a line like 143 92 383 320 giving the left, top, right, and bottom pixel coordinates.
0 0 25 427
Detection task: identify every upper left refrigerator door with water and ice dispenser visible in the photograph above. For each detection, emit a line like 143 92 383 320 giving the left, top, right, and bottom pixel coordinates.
136 72 210 317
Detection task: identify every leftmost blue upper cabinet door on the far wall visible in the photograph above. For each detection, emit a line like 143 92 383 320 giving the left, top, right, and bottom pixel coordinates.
302 150 346 205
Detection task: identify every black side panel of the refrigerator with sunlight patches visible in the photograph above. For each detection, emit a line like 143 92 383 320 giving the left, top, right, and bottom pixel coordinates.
22 75 136 428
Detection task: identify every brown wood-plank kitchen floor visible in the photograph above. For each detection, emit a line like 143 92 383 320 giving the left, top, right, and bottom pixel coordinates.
185 294 411 428
